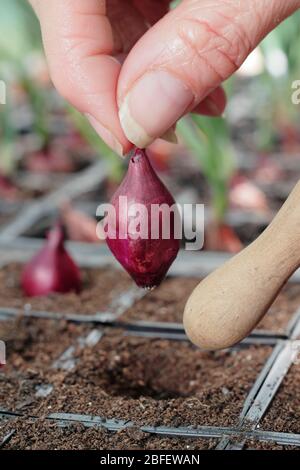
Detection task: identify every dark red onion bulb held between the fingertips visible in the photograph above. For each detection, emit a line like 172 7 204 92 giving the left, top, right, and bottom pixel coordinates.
107 149 180 289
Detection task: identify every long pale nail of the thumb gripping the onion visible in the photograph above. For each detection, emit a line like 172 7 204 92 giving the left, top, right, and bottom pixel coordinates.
119 70 194 148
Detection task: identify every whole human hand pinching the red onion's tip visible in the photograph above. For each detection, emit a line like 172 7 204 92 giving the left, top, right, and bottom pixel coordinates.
30 0 300 155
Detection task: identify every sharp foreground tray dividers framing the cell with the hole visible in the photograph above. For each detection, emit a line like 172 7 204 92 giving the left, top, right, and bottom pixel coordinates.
0 246 300 449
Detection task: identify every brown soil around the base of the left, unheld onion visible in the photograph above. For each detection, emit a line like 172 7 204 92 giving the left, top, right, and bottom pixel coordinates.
0 264 132 314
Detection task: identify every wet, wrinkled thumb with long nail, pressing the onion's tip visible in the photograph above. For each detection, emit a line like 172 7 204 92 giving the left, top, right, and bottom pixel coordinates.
118 0 300 148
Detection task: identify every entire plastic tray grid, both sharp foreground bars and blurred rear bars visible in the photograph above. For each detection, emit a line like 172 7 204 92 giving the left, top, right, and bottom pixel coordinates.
0 168 300 449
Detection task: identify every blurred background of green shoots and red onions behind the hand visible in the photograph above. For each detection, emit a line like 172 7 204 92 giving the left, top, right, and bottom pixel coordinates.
0 0 300 253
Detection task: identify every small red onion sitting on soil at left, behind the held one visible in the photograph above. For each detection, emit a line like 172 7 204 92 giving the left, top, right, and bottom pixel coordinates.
21 223 81 297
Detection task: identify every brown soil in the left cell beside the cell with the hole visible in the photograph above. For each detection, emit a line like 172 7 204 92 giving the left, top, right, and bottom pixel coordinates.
0 317 86 412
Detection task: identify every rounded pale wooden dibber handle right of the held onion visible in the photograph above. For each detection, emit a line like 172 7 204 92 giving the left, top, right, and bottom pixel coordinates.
183 181 300 350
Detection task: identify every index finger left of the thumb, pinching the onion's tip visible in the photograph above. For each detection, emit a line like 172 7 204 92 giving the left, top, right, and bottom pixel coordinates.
31 0 132 155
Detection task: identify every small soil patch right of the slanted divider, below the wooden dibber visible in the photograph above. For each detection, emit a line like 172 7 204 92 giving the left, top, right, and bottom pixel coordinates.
260 362 300 434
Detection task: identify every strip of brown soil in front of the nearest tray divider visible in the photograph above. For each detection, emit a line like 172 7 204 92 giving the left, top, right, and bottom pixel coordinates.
0 419 217 450
